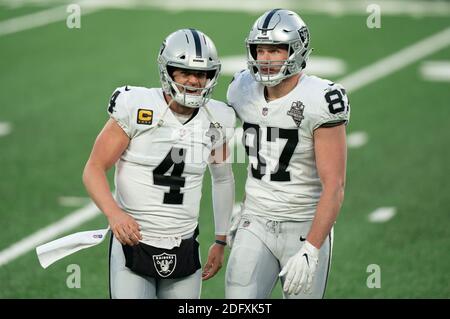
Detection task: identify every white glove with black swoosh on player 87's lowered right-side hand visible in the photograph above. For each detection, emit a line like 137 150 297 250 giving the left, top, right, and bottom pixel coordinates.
279 241 319 295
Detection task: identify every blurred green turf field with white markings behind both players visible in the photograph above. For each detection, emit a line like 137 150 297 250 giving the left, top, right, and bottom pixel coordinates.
0 0 450 298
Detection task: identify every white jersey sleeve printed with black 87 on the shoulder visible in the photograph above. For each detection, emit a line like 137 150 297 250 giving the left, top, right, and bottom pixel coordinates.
310 83 350 132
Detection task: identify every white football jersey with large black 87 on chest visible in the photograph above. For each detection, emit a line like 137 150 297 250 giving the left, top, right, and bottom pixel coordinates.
227 70 350 221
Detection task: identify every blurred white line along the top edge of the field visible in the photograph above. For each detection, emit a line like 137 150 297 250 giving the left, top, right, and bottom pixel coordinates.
0 0 450 17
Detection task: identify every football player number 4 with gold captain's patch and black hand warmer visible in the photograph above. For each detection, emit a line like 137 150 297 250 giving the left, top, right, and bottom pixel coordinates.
83 29 236 299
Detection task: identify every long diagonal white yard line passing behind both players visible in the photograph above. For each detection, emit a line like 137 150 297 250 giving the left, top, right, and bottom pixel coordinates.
0 24 450 266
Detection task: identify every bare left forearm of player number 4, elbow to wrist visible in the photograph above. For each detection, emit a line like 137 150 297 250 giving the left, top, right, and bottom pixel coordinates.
83 162 120 218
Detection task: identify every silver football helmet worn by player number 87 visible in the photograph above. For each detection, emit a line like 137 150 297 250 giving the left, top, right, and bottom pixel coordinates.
245 9 312 86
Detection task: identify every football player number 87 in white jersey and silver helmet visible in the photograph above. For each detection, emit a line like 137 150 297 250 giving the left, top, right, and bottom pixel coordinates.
226 9 349 298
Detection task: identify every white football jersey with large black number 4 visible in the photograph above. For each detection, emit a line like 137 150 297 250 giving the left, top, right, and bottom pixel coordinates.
108 86 236 242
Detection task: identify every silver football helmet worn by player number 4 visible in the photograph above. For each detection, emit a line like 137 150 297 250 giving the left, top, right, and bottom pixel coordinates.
158 29 221 108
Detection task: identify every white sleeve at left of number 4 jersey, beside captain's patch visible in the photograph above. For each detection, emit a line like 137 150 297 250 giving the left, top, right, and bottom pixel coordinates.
108 87 134 138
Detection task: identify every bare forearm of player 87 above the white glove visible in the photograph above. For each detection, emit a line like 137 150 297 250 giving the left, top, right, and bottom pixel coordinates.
307 183 344 248
